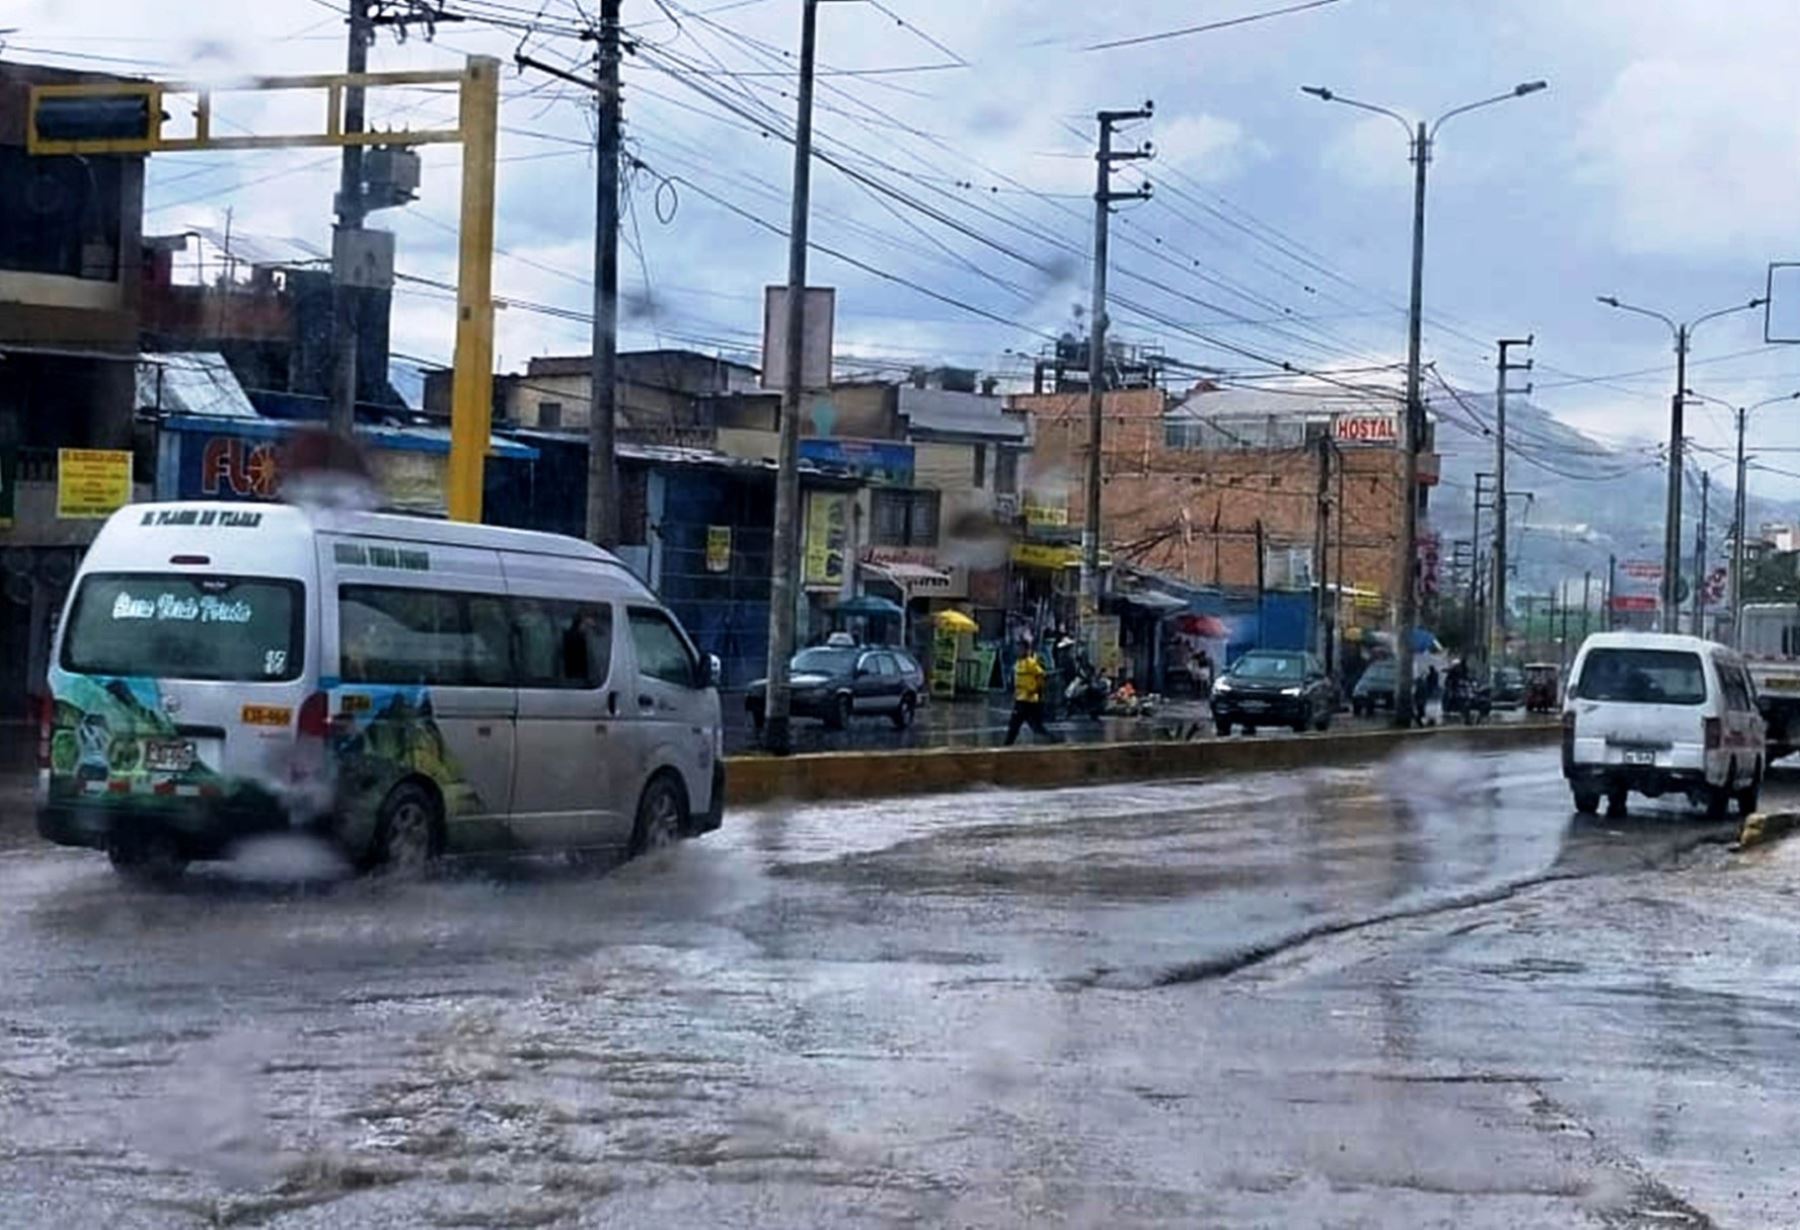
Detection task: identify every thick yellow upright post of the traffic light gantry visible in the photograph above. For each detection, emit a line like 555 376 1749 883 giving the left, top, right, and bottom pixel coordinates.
446 56 500 520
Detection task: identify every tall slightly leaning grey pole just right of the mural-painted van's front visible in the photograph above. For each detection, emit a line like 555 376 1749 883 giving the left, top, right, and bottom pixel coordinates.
763 0 819 756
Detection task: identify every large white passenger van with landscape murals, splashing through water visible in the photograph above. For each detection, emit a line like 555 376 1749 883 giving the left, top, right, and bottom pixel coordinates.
38 502 724 872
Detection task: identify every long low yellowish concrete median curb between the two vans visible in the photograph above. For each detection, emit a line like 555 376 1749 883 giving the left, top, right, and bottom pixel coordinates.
725 722 1559 807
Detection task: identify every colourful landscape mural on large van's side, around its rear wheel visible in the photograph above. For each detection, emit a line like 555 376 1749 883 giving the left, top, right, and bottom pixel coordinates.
320 684 482 816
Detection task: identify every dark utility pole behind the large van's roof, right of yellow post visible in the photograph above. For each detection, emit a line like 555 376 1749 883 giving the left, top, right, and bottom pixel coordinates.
587 0 623 547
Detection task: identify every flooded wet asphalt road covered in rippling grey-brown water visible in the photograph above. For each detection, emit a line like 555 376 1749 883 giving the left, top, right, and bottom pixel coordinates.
0 749 1800 1230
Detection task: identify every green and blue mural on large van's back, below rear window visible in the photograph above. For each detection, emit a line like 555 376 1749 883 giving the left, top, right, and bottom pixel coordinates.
50 668 221 801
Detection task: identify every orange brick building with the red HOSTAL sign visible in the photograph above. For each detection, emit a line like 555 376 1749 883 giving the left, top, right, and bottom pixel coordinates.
1013 382 1436 623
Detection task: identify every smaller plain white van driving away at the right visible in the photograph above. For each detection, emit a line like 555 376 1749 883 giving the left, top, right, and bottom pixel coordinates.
1562 632 1766 816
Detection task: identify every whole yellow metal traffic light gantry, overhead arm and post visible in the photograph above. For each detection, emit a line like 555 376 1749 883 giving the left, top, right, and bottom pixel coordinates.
25 56 500 520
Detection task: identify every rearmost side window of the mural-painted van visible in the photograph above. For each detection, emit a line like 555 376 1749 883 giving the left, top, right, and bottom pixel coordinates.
338 585 511 688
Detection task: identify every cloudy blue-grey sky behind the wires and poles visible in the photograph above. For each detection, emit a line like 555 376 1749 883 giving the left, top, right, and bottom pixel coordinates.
10 0 1800 493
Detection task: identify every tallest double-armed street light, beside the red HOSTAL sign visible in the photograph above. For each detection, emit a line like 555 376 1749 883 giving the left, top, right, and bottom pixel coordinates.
1300 81 1548 726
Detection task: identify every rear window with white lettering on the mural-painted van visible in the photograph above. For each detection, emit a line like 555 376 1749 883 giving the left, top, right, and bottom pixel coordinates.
63 573 306 683
